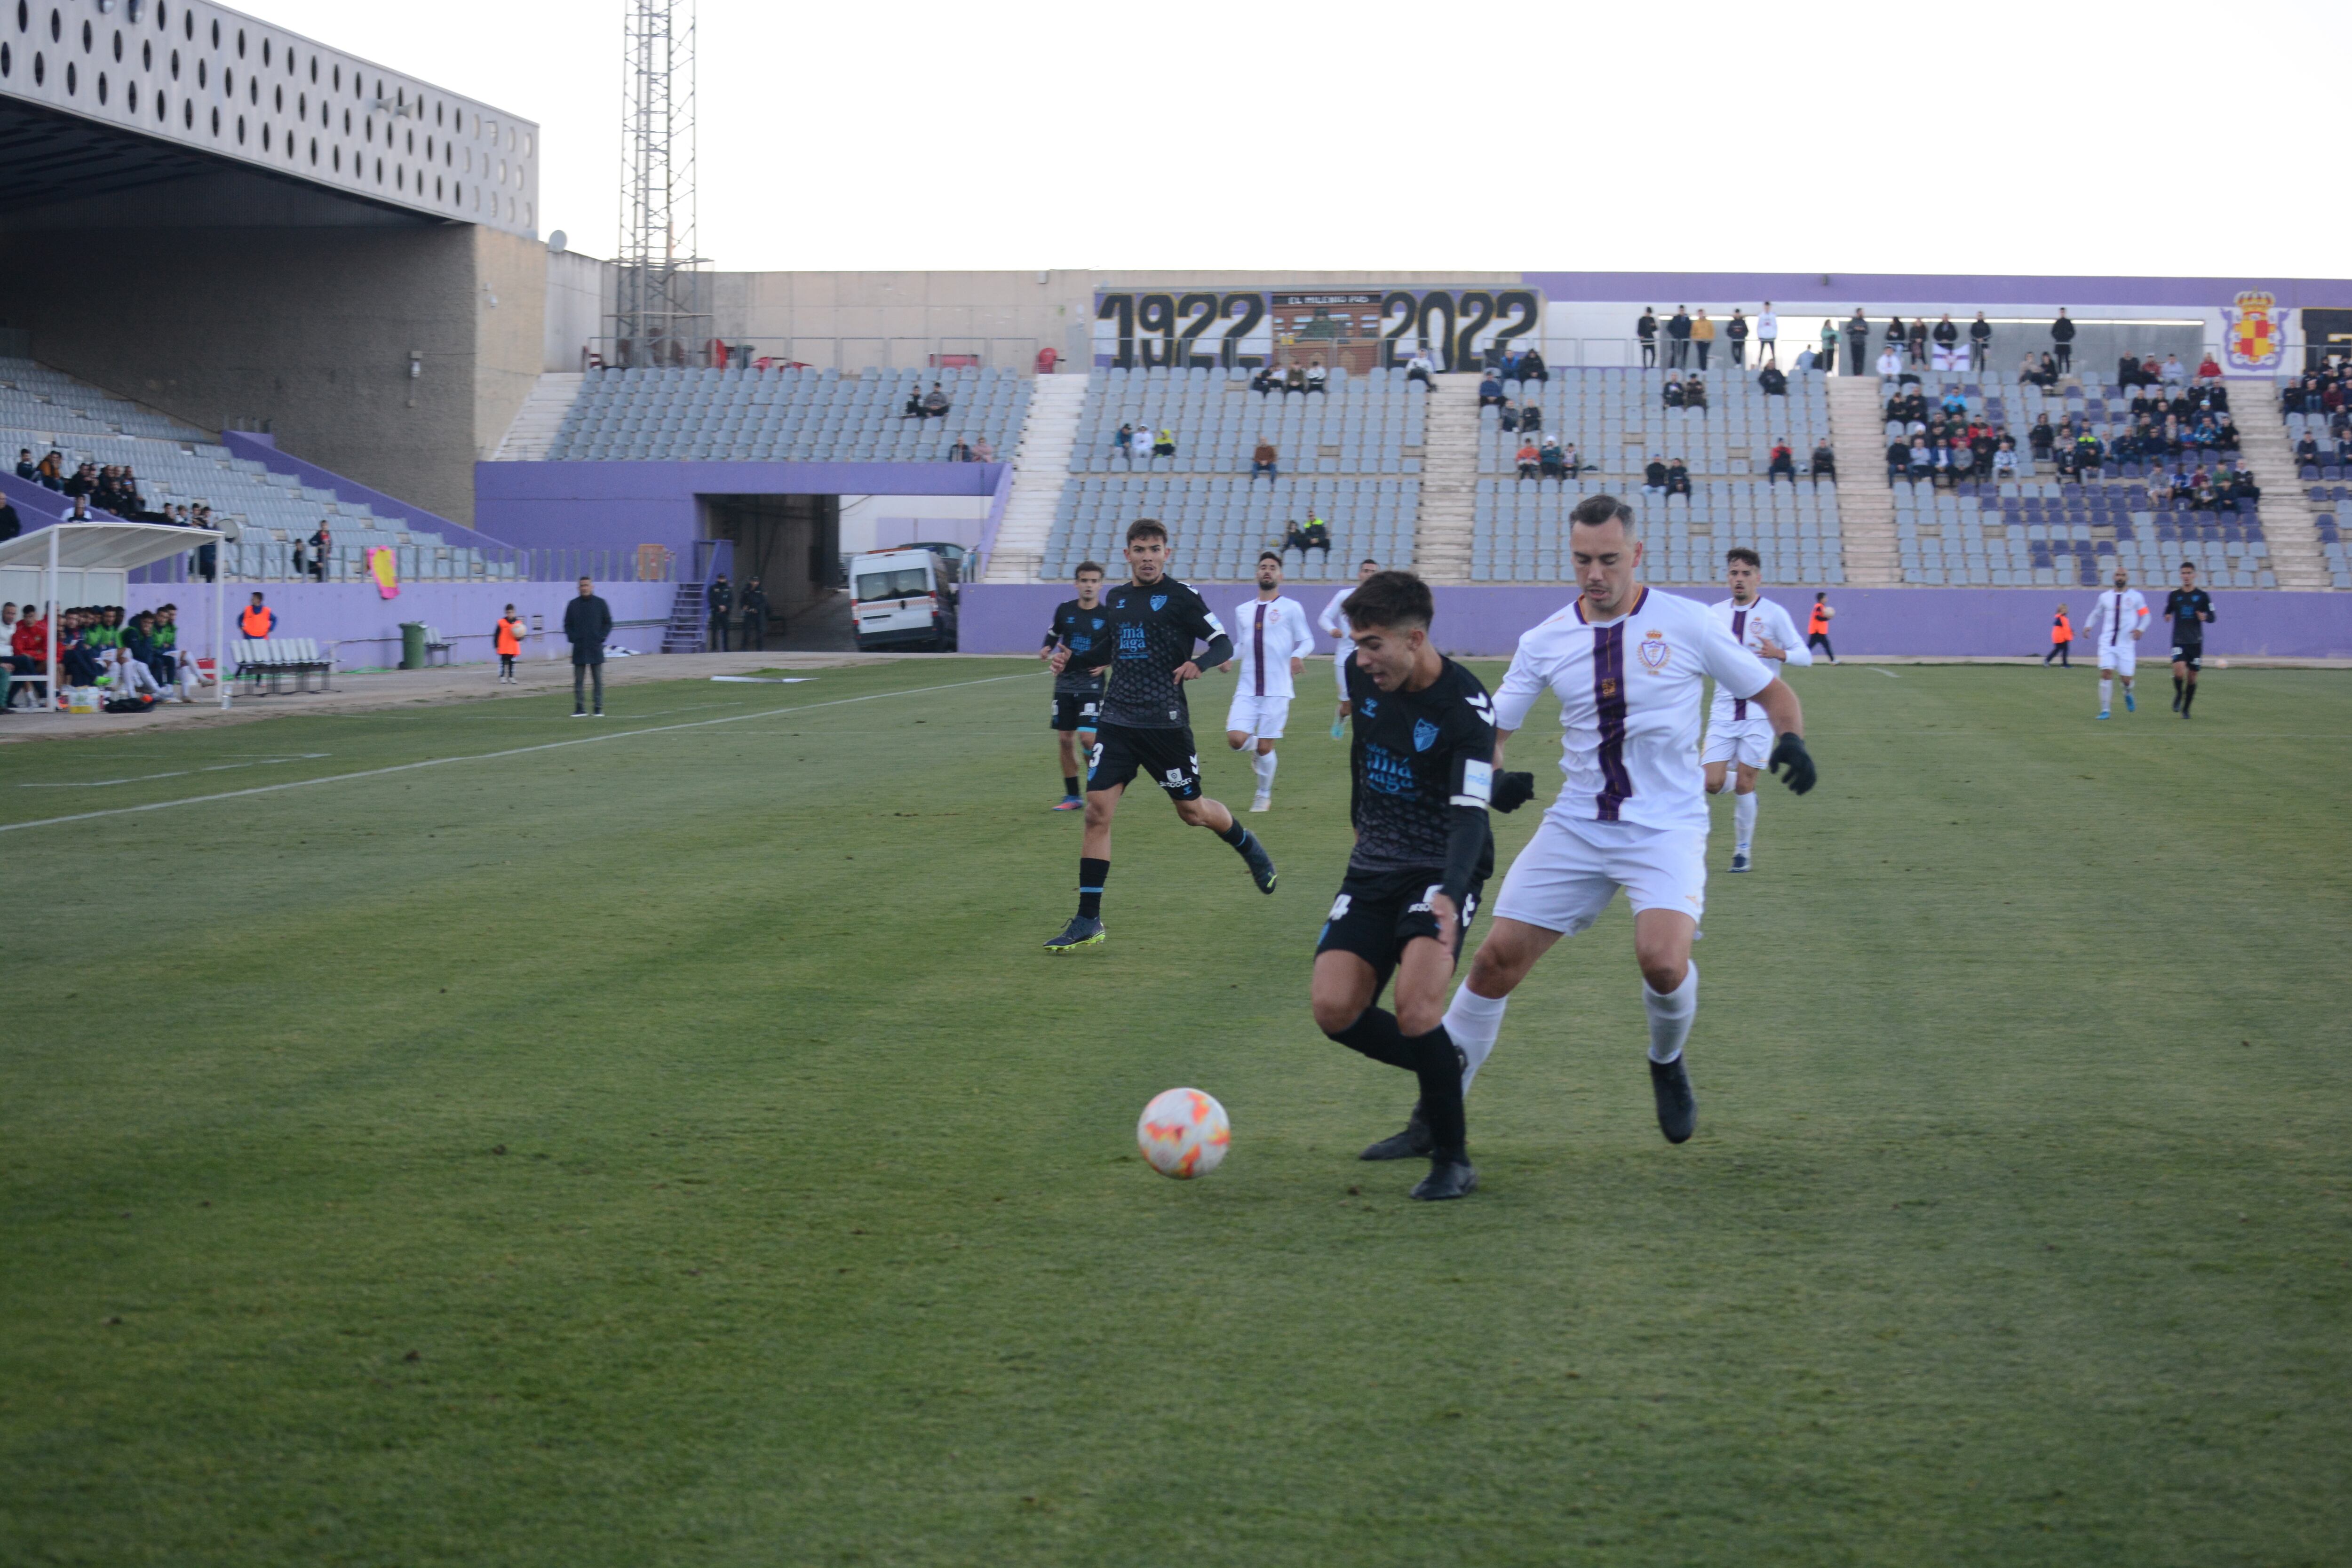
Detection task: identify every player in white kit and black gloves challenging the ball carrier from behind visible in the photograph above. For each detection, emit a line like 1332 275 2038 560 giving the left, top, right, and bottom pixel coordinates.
1411 496 1813 1143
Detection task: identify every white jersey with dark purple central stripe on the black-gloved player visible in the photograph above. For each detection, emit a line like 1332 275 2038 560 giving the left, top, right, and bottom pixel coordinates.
1494 588 1773 832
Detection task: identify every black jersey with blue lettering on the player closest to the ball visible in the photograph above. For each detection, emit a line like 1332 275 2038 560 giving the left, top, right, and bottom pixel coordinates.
1345 656 1494 879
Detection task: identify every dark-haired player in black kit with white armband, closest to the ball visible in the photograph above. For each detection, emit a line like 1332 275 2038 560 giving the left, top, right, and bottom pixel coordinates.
1312 571 1534 1199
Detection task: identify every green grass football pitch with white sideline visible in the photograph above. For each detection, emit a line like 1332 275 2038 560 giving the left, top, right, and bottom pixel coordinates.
0 658 2352 1568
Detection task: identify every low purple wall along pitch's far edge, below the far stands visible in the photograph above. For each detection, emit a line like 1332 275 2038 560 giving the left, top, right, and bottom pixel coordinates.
962 583 2352 658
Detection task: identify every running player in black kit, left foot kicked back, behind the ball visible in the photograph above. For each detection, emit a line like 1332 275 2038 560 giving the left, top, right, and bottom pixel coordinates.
1044 517 1275 952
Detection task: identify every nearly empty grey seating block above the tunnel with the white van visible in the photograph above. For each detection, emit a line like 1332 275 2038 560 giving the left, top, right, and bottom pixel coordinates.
546 367 1030 463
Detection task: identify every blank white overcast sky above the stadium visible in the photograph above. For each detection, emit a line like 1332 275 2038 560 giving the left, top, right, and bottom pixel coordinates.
249 0 2352 278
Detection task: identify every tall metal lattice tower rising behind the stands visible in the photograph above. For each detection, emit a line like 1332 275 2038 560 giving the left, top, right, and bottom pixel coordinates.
612 0 710 365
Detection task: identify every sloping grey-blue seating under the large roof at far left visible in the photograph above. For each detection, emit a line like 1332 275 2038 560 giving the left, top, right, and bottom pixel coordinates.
0 360 517 581
